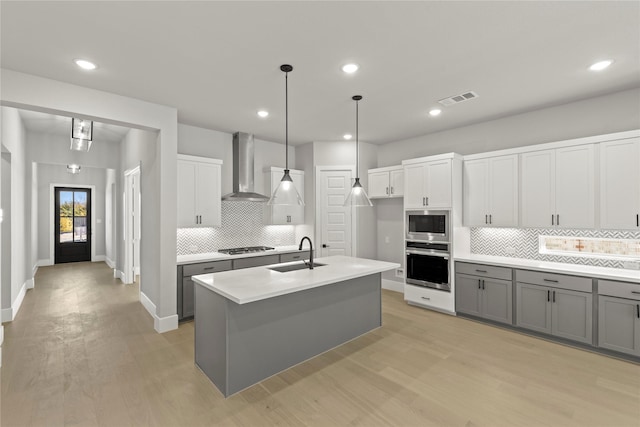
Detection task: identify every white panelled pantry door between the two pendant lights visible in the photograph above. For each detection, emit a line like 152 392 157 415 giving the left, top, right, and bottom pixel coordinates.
316 168 352 257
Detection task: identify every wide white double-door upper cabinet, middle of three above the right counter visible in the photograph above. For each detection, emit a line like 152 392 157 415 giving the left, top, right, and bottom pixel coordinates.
520 144 595 228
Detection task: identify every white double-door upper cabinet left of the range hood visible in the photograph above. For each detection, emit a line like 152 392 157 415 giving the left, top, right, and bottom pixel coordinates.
177 154 222 227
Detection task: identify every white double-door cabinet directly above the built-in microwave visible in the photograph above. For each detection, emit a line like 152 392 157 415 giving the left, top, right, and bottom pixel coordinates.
404 159 451 209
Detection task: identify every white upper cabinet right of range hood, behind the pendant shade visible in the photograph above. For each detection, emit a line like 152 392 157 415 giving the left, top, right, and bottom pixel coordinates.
264 167 304 225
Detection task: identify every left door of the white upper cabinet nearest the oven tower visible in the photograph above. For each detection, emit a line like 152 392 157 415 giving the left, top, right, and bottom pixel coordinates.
462 159 489 227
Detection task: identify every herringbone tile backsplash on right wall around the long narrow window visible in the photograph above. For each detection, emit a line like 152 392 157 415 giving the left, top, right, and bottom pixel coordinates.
471 227 640 268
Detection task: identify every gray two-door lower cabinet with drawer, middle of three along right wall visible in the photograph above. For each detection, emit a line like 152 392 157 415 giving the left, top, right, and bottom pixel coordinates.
516 270 593 344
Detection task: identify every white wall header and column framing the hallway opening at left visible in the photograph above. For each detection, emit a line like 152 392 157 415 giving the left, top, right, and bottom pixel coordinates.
0 69 178 331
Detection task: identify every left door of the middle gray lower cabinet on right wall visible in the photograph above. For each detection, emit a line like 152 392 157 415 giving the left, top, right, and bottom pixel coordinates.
516 283 551 334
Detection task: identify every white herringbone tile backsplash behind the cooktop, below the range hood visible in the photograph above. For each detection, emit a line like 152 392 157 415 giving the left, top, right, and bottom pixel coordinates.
177 201 296 255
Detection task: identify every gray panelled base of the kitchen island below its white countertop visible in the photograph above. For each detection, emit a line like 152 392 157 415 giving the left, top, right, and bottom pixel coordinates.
195 274 382 396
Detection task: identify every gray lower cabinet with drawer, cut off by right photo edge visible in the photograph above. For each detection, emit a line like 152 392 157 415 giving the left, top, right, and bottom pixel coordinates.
598 280 640 356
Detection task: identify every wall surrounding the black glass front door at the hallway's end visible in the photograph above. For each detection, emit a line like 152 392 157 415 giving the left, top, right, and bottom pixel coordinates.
37 164 106 264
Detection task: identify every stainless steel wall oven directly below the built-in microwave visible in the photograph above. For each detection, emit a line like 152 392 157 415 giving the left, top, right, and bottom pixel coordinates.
406 240 451 292
